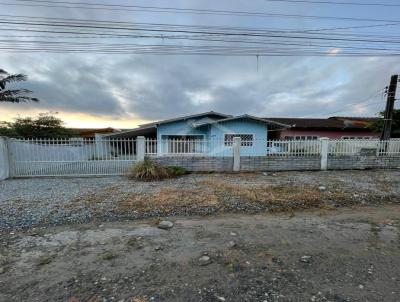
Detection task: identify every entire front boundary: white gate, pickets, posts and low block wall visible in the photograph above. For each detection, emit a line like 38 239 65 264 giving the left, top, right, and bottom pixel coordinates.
0 135 400 179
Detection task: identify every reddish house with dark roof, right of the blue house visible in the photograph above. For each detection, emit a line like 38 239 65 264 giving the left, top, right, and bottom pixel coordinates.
267 117 380 140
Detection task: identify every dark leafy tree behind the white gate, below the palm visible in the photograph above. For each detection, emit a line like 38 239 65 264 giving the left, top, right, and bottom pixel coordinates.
0 113 79 138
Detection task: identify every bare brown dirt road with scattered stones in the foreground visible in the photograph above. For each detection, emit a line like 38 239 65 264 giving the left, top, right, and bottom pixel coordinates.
0 205 400 302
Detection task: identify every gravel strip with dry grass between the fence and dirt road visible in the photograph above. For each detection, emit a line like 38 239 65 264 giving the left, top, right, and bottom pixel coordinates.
0 170 400 230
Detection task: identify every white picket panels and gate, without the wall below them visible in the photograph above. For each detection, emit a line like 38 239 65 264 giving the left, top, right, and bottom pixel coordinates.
3 138 400 177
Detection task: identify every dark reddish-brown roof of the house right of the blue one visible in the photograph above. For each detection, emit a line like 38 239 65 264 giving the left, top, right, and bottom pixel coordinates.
266 117 376 130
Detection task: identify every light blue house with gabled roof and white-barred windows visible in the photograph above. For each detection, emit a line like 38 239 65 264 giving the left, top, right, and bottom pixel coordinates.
108 111 289 156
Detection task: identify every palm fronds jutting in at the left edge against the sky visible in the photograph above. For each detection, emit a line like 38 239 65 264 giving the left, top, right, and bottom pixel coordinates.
0 68 39 103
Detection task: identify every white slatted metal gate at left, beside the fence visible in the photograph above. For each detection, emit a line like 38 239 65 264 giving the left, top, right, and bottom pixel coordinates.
9 139 136 177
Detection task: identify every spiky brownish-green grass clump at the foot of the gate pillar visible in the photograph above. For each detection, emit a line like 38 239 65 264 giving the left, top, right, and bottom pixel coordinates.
128 160 169 181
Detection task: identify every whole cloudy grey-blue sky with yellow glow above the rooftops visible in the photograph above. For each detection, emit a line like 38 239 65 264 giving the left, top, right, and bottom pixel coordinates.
0 0 400 128
